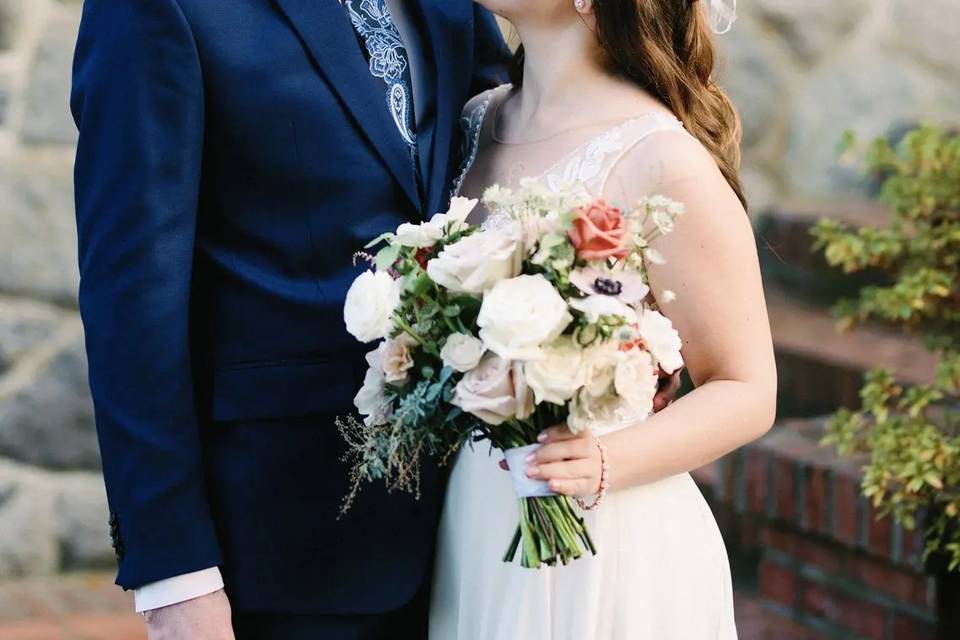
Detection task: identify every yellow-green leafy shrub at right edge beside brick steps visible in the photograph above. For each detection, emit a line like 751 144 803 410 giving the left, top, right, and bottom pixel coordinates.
813 126 960 570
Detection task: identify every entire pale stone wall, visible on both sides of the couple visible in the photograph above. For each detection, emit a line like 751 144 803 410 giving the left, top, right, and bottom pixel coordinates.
0 0 960 578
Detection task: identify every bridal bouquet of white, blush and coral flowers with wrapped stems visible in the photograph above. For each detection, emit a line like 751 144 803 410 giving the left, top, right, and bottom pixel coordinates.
339 180 683 568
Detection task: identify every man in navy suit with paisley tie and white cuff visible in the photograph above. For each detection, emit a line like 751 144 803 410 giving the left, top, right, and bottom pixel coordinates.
71 0 509 640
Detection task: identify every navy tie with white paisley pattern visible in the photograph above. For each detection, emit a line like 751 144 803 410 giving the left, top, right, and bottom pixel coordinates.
342 0 420 169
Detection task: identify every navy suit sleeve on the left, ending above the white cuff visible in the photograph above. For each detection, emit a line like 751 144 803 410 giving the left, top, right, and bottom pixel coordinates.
71 0 220 588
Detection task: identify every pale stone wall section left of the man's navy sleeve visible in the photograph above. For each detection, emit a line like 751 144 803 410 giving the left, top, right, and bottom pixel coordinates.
0 0 112 578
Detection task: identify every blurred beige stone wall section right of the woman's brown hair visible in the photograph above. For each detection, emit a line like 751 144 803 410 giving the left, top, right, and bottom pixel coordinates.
719 0 960 210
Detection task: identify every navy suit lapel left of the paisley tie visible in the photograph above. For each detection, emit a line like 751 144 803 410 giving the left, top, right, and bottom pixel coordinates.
274 0 421 211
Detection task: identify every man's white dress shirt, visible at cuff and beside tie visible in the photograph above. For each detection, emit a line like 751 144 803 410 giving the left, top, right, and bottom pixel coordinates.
133 0 429 613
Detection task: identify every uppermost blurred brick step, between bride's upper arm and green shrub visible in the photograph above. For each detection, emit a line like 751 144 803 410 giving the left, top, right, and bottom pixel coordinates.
754 201 888 305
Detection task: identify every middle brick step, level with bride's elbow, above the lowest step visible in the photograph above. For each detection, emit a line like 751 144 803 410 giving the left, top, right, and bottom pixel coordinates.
766 286 936 417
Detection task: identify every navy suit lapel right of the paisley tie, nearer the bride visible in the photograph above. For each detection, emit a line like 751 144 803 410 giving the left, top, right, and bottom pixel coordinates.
411 0 474 214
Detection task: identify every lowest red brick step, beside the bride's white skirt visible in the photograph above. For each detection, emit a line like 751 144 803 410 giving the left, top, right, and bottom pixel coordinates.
694 419 960 640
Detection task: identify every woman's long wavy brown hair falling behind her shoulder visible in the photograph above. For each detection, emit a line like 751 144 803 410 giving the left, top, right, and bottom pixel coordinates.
510 0 747 207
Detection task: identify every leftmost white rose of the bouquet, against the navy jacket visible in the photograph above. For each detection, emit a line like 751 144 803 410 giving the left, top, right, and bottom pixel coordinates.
343 271 400 342
